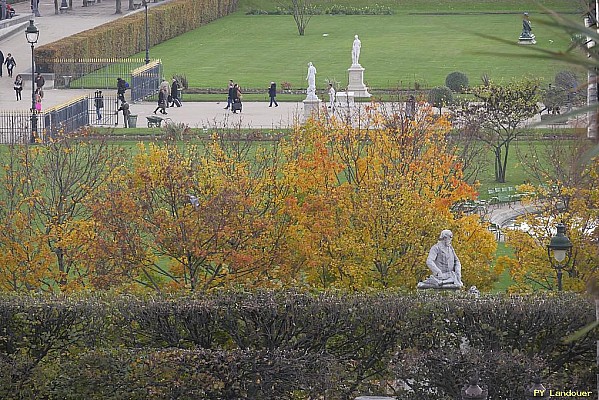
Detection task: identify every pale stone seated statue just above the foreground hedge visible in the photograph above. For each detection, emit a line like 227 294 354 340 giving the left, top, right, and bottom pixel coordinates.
418 229 464 289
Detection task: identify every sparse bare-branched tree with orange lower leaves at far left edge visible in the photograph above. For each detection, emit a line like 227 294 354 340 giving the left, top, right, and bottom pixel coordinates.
0 131 122 291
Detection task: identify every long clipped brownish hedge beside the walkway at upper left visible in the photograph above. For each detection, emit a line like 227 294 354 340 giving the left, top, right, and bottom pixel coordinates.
36 0 238 72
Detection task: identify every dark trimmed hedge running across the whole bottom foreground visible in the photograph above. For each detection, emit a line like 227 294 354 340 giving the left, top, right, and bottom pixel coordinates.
0 292 595 400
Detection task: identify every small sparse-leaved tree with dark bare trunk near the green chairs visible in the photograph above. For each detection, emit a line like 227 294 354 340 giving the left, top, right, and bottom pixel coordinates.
454 79 539 183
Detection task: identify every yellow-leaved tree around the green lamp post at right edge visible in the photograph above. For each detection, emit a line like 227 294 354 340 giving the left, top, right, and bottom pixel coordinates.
498 137 599 291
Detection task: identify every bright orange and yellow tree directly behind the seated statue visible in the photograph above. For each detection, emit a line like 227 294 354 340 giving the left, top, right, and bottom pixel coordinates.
289 105 495 289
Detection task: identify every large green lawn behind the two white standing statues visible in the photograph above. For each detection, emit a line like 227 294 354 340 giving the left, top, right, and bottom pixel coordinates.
140 0 578 90
